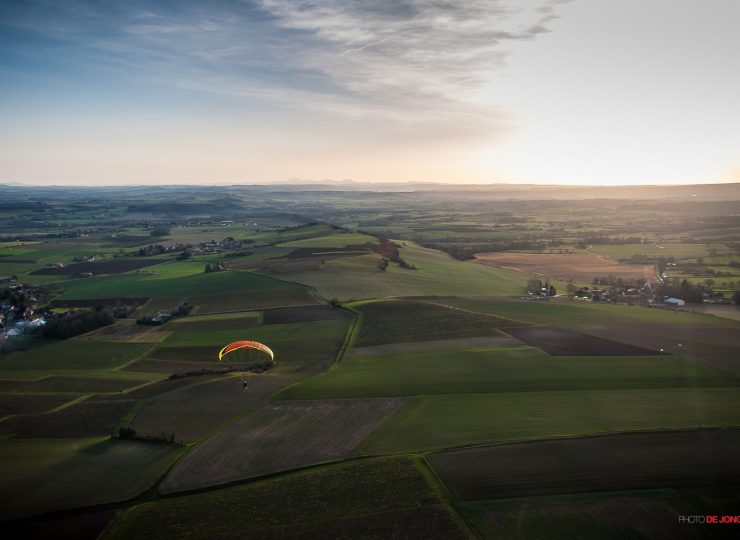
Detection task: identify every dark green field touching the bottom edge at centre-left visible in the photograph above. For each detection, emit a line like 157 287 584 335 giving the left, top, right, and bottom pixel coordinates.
103 457 471 540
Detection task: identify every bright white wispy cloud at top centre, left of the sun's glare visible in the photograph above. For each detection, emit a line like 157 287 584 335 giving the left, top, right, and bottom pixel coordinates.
258 0 553 105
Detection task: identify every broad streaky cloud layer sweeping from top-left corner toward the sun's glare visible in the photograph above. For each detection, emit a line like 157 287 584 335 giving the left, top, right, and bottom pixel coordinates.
0 0 564 136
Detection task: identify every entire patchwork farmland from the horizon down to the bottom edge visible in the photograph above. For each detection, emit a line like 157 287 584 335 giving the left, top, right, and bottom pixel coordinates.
0 186 740 539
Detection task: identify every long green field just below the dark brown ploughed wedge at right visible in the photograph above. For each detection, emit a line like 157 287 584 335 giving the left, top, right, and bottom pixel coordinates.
281 345 740 399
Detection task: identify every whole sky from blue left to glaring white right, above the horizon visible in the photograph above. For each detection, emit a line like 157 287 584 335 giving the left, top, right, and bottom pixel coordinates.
0 0 740 185
